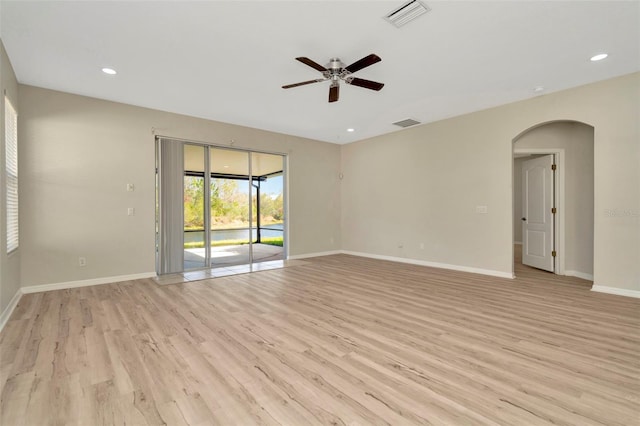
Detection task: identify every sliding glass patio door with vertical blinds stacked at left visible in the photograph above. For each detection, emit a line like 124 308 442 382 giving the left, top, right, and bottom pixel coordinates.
157 138 286 274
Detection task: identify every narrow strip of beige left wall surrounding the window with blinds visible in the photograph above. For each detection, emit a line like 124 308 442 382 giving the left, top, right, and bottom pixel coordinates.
0 40 23 313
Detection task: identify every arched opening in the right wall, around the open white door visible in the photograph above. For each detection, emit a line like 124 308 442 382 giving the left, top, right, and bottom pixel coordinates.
512 121 594 280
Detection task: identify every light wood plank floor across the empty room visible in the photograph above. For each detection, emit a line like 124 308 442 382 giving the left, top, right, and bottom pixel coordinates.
0 255 640 426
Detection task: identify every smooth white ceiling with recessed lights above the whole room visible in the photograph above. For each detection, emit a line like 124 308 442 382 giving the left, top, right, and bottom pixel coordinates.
0 0 640 144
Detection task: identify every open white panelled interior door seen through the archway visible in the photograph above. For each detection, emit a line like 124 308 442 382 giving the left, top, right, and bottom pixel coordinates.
522 155 554 272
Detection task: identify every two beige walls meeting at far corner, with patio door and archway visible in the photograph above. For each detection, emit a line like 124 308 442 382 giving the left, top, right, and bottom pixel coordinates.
12 60 640 290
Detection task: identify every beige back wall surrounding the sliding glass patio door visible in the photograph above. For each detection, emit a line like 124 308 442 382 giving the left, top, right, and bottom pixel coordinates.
19 86 340 286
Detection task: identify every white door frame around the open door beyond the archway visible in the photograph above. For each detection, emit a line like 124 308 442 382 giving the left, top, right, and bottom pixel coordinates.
511 147 565 276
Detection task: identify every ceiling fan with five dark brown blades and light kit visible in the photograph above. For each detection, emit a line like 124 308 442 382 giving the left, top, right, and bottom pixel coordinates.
282 53 384 102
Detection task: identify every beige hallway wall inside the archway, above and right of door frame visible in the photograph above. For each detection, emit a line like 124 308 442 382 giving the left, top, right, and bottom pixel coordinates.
514 122 594 276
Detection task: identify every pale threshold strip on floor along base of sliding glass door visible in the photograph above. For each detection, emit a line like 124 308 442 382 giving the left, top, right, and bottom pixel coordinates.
153 259 307 285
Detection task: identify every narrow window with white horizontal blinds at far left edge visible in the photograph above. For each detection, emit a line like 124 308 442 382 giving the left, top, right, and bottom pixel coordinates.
4 96 19 253
